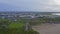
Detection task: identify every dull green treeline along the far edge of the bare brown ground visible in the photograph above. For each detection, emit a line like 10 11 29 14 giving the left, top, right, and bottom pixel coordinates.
30 17 60 25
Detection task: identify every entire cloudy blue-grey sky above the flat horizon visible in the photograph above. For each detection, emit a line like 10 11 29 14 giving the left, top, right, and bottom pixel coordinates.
0 0 60 12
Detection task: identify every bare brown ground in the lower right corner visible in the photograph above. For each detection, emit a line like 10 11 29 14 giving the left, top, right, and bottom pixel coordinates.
33 24 60 34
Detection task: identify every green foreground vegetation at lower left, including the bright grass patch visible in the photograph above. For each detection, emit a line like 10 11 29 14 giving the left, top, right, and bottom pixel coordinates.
0 19 38 34
